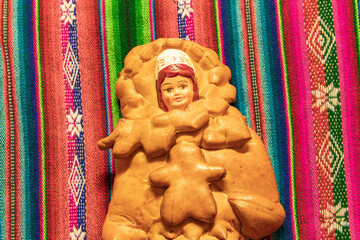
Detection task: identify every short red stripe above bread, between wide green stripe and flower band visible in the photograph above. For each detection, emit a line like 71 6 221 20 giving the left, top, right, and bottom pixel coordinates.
154 0 179 38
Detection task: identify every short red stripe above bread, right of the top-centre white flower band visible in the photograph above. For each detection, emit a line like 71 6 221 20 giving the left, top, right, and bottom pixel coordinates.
192 0 217 52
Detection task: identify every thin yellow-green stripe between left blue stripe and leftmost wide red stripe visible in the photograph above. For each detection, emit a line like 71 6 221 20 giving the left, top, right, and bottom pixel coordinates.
35 0 48 239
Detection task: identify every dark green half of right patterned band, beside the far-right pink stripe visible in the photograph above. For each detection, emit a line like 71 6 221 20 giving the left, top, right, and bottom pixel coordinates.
318 0 350 236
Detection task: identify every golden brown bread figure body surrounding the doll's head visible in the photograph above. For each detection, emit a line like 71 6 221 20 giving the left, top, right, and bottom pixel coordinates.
98 39 285 240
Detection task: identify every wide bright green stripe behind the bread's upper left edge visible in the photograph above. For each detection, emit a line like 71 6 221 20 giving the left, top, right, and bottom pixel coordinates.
105 0 151 126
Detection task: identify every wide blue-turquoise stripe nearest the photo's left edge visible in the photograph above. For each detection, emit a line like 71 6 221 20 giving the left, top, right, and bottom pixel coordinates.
13 0 40 239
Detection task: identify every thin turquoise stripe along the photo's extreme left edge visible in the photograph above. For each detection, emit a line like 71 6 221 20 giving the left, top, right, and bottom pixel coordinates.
0 25 6 239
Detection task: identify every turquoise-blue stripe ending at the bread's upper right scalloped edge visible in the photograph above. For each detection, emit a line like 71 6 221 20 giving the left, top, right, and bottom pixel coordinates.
225 0 251 122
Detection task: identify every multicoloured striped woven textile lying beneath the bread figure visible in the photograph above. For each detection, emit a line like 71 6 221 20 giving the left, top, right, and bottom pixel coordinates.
0 0 360 239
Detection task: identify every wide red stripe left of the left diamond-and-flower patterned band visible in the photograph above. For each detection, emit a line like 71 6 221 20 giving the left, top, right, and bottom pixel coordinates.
39 0 69 236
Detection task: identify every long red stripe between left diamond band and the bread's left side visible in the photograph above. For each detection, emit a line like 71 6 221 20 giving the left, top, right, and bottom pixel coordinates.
77 0 109 239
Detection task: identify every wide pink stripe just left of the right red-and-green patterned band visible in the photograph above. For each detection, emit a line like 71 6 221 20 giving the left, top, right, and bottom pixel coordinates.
282 0 321 239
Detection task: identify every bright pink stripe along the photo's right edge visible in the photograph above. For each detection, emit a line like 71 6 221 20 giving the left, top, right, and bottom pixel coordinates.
332 0 360 239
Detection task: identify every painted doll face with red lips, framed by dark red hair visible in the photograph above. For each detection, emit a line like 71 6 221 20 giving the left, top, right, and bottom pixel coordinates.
160 75 194 111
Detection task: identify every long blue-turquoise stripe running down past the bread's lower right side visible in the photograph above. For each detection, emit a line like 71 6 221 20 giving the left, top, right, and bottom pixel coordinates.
255 0 292 239
